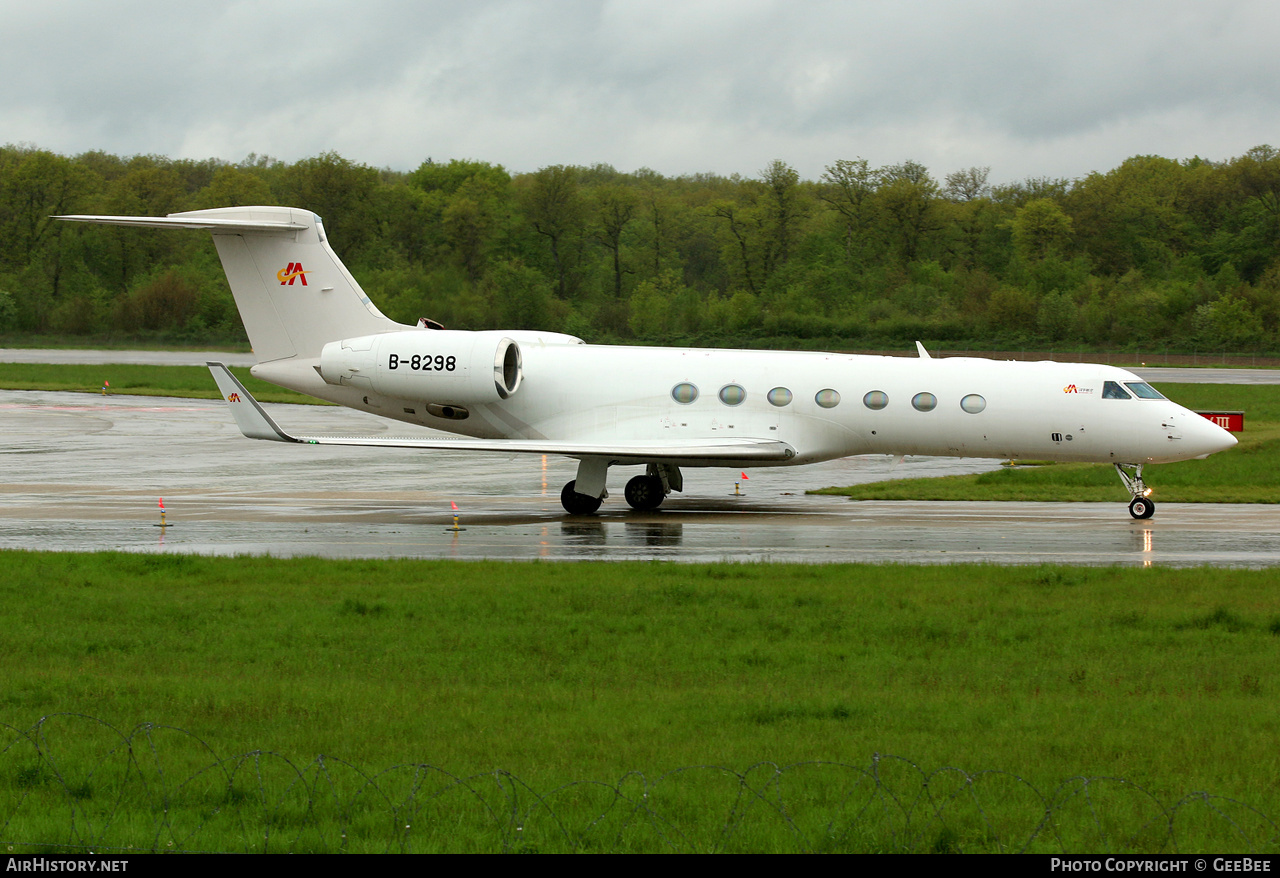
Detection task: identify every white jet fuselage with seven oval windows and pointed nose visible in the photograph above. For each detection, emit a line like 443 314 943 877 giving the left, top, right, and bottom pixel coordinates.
253 343 1234 466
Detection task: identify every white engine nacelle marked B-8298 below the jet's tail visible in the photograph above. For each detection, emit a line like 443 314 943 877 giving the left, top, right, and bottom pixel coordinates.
320 329 524 406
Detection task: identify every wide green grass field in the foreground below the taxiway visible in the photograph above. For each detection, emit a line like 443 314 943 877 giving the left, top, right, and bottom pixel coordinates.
0 552 1280 851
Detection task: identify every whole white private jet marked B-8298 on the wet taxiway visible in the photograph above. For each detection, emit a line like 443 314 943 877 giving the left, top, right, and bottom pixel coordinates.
59 207 1235 518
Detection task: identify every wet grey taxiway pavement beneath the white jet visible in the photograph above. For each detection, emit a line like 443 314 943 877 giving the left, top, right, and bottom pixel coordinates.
0 392 1280 567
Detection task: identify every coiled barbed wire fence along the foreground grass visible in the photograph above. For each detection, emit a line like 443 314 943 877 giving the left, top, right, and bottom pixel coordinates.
0 713 1280 854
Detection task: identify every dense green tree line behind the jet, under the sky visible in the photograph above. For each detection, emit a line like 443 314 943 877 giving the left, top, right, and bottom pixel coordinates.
0 145 1280 352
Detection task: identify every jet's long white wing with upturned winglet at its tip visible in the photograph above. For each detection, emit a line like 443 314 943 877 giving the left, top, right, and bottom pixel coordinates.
205 362 796 463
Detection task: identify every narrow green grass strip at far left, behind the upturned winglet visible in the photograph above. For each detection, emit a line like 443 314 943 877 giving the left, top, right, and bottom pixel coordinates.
0 362 320 404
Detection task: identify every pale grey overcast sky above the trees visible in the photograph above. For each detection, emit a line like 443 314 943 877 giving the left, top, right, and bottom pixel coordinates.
0 0 1280 183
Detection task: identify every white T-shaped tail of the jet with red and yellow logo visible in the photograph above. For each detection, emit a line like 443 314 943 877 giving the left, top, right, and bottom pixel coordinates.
58 207 410 363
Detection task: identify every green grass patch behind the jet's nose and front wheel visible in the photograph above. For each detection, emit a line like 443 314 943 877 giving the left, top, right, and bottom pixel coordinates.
812 384 1280 503
